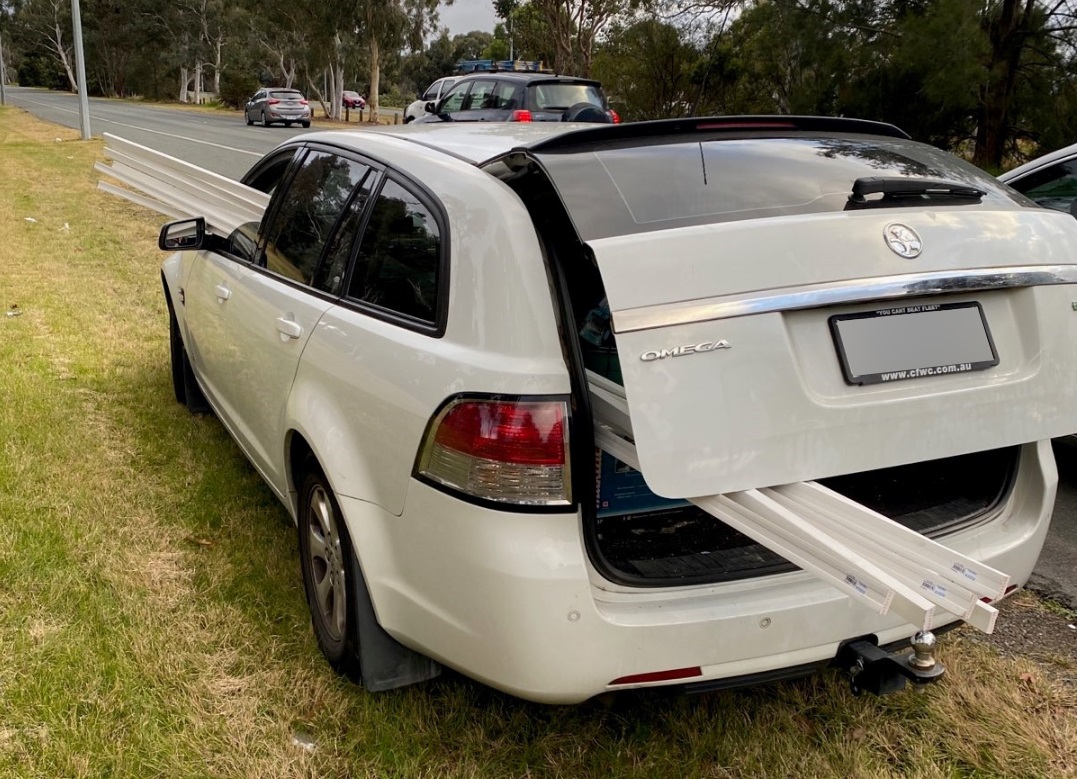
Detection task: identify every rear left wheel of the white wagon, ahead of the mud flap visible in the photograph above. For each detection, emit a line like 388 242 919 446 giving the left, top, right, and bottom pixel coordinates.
297 461 362 682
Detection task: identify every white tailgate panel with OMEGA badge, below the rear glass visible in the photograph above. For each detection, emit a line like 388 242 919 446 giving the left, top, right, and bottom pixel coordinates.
591 209 1077 498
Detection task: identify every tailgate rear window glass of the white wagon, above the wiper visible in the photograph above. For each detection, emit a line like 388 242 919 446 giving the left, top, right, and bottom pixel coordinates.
539 136 1025 240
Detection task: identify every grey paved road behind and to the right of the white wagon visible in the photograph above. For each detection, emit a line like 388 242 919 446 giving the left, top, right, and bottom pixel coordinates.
8 87 1077 609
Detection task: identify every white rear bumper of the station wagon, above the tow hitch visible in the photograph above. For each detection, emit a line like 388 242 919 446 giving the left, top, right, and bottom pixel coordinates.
340 442 1058 703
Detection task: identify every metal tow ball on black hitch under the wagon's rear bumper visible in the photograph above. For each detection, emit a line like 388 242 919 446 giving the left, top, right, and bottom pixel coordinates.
835 630 946 695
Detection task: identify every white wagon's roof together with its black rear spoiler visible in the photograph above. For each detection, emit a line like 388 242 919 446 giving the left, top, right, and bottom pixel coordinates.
296 116 909 165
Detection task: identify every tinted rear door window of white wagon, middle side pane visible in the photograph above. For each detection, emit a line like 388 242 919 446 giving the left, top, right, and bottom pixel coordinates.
265 150 367 284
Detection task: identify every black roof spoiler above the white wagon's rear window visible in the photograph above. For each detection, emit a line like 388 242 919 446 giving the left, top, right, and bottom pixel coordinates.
528 115 910 152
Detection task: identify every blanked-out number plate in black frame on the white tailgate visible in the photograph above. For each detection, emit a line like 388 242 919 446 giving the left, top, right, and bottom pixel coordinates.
829 303 998 385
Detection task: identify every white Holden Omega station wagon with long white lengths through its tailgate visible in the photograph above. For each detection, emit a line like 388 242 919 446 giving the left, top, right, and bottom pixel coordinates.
154 116 1077 703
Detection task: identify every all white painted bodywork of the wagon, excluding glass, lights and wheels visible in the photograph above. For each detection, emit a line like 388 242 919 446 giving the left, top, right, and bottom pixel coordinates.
136 124 1077 703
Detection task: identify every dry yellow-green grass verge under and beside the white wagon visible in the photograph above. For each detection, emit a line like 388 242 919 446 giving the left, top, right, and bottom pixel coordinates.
0 109 1077 779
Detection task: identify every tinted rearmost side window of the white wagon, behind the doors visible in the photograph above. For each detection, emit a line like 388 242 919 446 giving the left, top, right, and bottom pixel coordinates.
348 180 442 322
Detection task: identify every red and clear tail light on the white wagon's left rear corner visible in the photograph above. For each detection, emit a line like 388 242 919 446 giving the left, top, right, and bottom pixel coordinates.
417 398 572 506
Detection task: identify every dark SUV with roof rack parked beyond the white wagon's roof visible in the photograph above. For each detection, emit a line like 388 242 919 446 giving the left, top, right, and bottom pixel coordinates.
416 71 620 124
